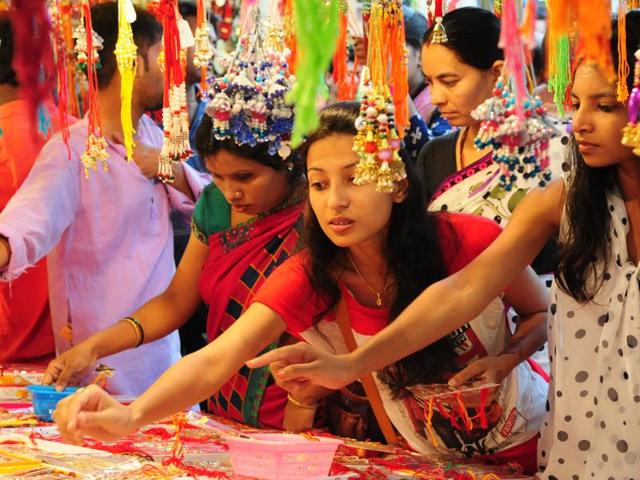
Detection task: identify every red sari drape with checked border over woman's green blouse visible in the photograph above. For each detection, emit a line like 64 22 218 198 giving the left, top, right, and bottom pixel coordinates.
199 188 304 428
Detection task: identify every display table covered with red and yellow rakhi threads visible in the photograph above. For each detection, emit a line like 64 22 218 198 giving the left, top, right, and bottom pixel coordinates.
0 366 527 480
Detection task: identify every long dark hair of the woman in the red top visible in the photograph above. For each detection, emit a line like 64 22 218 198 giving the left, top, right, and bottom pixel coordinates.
300 102 456 396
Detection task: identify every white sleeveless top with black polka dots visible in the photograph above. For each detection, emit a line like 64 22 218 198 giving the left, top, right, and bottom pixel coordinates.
538 186 640 480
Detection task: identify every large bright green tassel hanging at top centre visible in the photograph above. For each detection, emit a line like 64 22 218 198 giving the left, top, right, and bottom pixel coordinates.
287 0 340 147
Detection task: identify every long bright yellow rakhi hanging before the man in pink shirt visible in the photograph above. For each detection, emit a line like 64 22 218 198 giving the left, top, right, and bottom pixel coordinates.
114 0 138 161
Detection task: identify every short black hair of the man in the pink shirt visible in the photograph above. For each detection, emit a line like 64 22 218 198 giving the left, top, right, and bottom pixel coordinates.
91 2 162 89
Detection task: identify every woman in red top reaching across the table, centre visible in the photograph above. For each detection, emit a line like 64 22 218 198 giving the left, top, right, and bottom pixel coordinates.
54 103 546 470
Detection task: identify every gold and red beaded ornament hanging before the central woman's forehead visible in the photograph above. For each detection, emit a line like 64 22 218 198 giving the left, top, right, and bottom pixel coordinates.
353 68 407 192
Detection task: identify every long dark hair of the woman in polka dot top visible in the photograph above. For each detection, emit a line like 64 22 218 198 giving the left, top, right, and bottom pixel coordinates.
556 10 640 302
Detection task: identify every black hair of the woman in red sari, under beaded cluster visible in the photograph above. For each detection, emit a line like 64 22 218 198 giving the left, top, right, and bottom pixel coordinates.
195 115 303 183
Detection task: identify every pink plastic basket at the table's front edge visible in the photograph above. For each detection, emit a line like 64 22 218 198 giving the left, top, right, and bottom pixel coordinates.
225 433 342 480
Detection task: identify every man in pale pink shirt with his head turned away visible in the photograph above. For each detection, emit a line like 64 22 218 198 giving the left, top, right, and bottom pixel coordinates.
0 3 208 396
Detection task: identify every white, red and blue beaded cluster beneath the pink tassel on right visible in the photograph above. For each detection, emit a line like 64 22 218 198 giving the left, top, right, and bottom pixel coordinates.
471 77 555 191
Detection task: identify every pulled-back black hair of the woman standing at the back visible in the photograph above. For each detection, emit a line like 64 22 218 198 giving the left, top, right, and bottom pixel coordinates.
423 7 504 70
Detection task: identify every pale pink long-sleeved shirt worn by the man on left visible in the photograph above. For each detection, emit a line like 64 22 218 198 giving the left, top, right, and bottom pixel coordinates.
0 116 208 395
